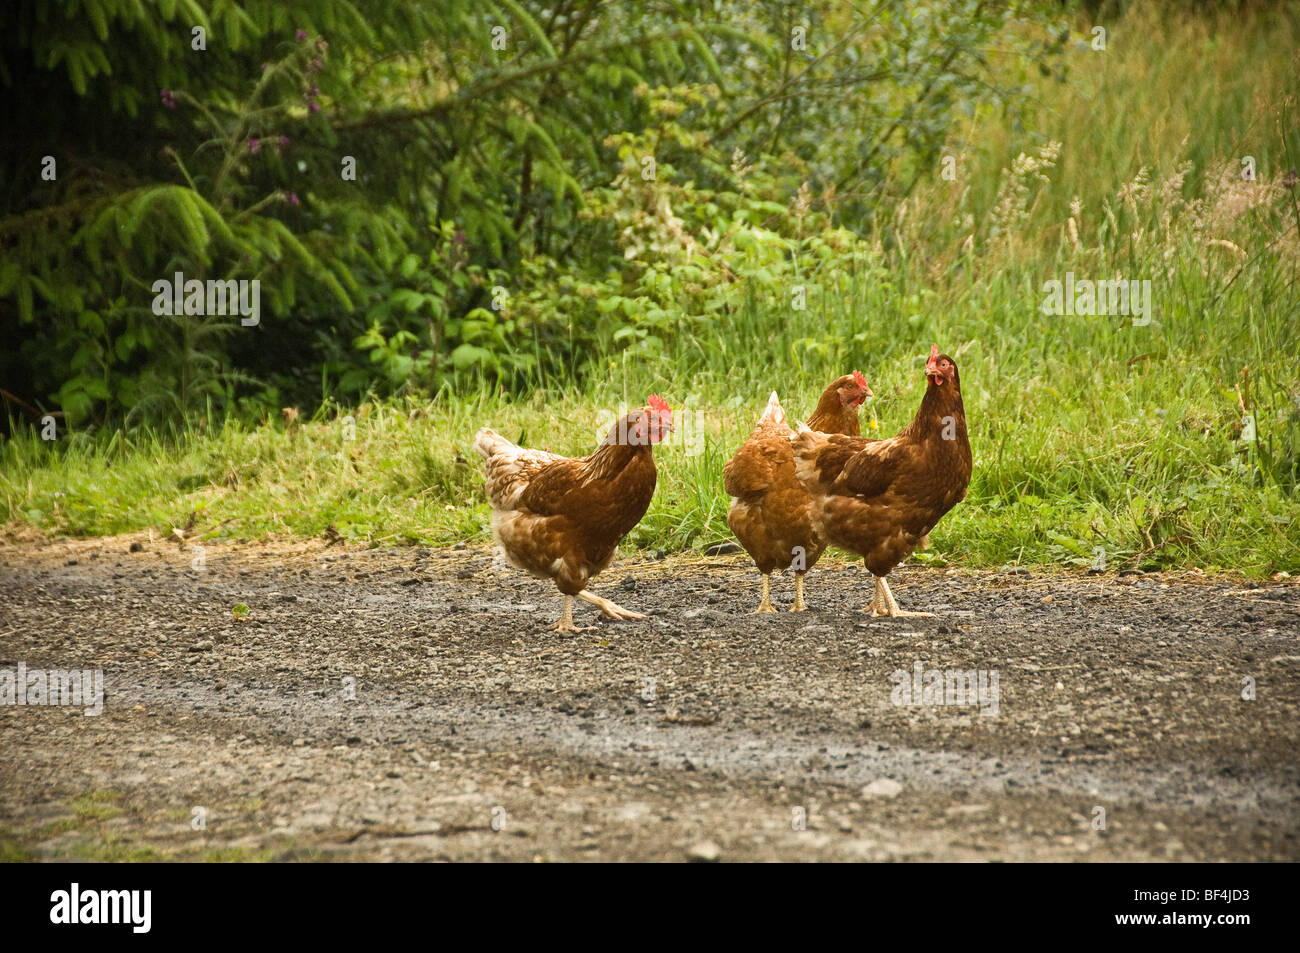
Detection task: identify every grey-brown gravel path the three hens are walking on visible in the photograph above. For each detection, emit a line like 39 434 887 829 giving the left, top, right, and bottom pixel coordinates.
0 537 1300 861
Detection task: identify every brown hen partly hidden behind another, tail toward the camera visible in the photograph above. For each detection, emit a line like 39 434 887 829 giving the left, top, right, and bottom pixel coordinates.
723 371 871 612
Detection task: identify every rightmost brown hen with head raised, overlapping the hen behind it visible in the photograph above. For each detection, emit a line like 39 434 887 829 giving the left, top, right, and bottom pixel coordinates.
790 345 971 616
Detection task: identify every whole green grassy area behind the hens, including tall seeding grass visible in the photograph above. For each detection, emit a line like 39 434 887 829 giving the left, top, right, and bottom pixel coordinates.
0 8 1300 576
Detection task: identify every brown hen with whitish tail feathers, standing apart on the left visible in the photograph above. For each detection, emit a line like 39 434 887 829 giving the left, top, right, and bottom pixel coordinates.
475 394 673 632
